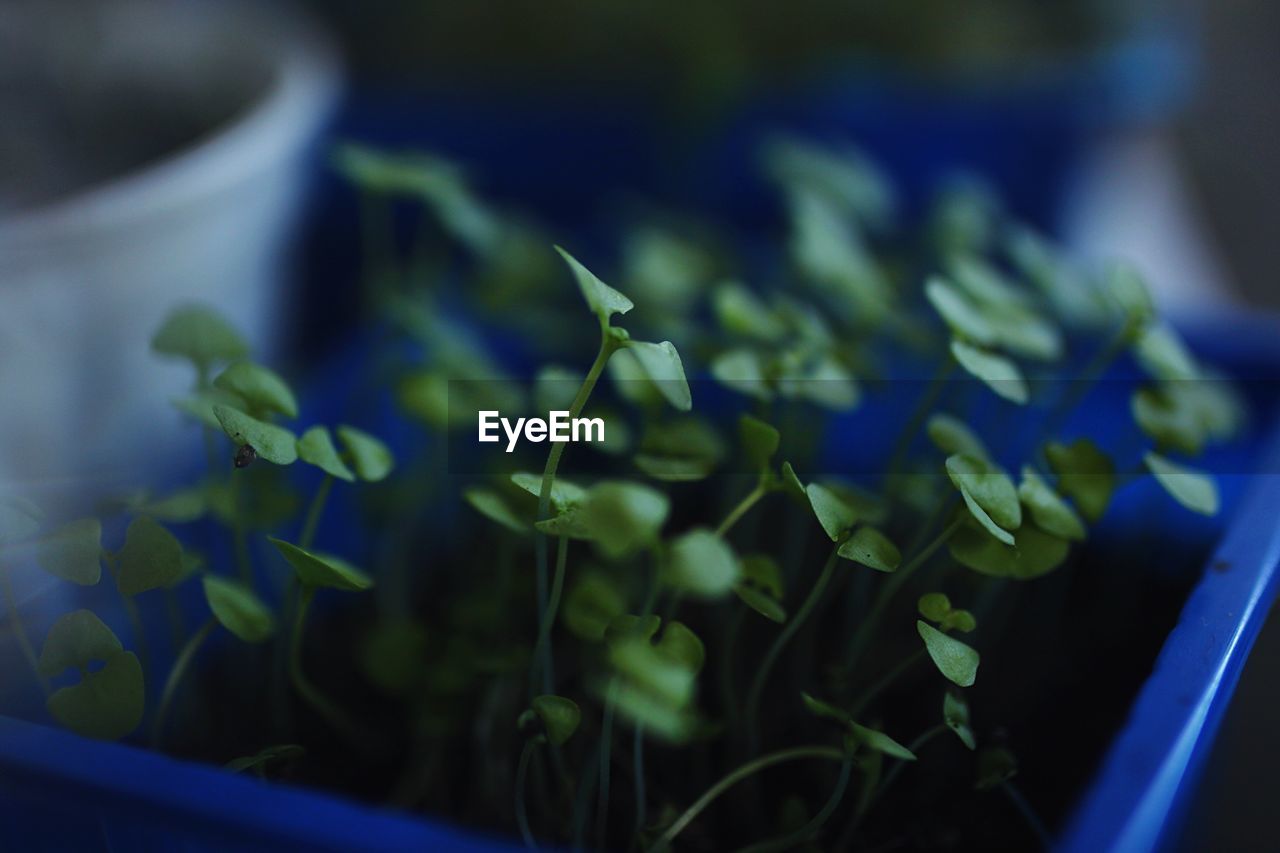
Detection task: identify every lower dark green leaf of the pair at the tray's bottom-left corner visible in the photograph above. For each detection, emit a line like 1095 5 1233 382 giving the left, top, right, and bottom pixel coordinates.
46 652 146 740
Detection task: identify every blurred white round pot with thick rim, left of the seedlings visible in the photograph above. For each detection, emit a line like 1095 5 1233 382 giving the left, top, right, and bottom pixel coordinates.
0 0 338 503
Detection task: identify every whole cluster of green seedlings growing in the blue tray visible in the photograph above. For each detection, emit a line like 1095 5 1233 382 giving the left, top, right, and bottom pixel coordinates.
0 141 1242 850
